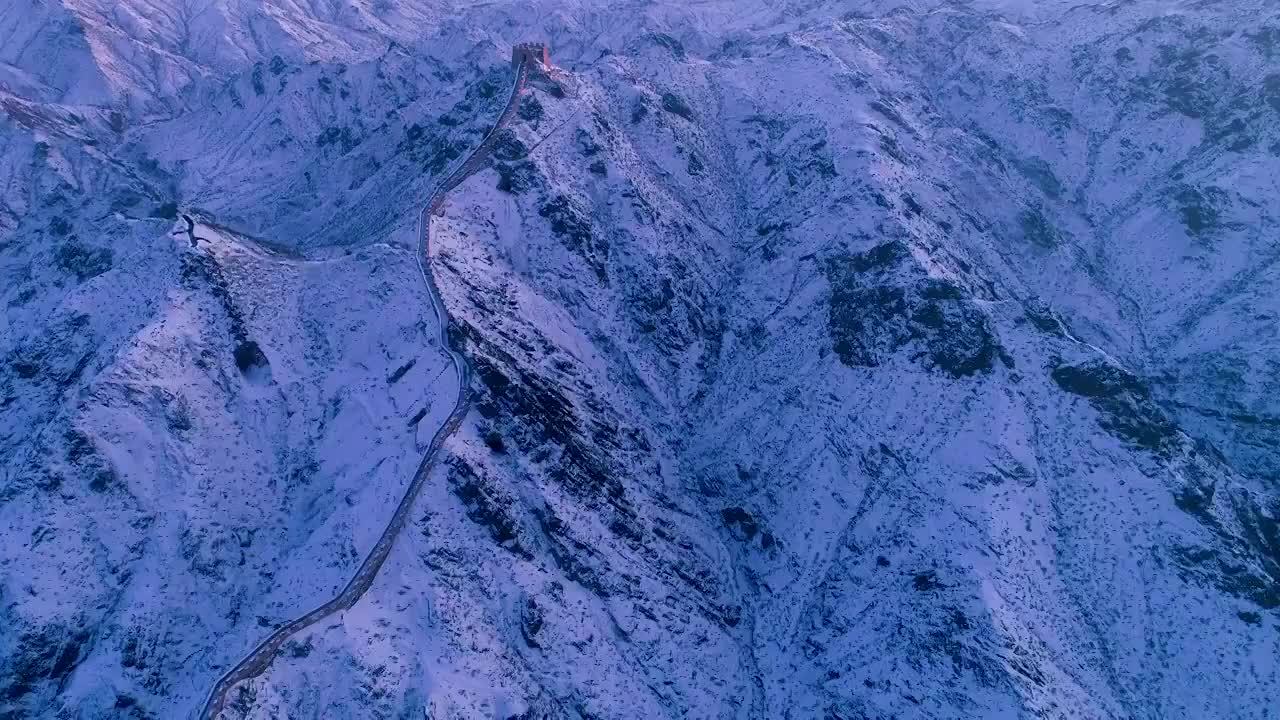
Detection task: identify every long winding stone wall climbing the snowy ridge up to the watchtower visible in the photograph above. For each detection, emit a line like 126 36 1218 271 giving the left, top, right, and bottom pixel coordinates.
200 51 532 720
